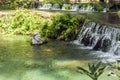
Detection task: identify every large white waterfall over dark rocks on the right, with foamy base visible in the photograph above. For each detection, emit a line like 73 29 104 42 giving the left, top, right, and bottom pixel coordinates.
75 21 120 61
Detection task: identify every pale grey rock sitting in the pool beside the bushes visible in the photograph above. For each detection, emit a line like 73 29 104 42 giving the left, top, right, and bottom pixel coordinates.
32 33 44 45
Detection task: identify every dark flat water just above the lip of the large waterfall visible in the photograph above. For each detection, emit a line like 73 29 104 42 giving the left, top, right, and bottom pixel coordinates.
83 13 120 27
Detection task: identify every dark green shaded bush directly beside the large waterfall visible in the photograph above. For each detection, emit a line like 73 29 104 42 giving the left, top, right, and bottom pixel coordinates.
41 14 85 40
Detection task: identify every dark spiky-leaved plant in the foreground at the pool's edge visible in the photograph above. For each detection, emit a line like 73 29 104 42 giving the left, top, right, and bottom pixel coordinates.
77 62 106 80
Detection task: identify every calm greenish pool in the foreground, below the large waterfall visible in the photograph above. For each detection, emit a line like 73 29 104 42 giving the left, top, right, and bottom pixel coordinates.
0 36 118 80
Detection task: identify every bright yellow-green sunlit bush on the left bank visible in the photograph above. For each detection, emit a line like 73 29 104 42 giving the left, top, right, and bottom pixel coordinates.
1 10 45 34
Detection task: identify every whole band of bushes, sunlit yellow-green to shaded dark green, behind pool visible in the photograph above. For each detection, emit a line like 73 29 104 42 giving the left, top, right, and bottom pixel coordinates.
0 10 85 40
